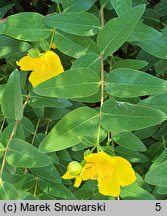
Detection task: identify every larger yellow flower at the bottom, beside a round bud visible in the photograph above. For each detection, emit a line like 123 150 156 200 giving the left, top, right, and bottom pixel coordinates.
62 152 136 197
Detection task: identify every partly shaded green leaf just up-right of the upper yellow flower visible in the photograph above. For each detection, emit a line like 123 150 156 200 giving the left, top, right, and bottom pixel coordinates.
54 31 99 58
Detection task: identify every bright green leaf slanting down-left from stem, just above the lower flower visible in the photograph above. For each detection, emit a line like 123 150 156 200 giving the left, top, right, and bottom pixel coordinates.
39 107 98 152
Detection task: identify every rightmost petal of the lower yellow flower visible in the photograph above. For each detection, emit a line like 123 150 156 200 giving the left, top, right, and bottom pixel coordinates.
115 157 136 186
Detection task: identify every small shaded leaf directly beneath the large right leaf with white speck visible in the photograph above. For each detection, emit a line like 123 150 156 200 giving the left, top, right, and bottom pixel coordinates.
112 132 147 151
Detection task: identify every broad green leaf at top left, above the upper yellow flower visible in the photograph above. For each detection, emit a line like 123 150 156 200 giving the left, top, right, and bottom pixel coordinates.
3 12 51 41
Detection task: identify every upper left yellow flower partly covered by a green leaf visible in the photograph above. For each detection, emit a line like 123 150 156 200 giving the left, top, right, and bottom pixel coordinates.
16 51 64 87
